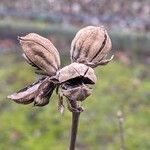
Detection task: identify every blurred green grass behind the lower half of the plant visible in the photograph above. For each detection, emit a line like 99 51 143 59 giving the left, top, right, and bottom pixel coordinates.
0 54 150 150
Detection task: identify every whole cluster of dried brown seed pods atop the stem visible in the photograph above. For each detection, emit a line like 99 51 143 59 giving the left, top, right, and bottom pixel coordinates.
8 26 113 150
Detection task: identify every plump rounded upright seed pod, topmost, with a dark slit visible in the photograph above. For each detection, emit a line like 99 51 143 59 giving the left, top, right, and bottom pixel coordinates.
70 26 111 67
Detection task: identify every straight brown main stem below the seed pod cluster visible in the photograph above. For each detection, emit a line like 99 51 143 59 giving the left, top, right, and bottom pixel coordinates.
69 112 80 150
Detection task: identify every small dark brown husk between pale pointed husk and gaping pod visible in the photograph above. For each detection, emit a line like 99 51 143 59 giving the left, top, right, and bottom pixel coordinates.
34 77 56 106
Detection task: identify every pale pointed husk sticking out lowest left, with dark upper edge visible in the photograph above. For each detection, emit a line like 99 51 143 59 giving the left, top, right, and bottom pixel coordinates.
7 79 43 104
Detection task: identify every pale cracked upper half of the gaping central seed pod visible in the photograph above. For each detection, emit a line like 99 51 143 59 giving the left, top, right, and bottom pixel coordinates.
58 63 96 84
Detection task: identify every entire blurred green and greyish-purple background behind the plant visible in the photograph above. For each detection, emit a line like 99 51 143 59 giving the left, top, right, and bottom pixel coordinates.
0 0 150 150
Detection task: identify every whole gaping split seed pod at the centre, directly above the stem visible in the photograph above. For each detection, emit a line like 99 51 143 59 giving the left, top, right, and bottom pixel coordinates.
58 63 96 101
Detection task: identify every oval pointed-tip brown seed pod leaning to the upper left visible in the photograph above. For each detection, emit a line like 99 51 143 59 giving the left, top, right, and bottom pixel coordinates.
18 33 60 76
